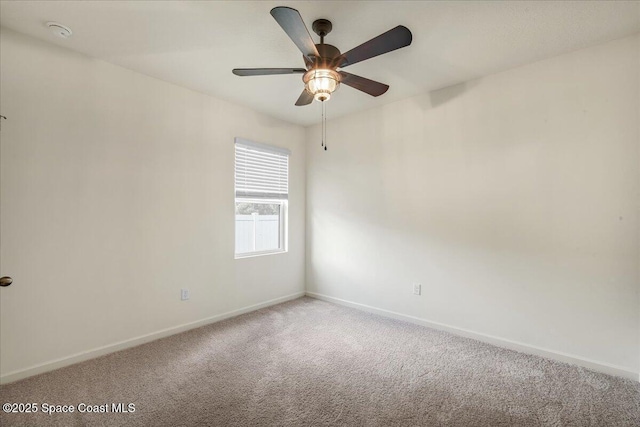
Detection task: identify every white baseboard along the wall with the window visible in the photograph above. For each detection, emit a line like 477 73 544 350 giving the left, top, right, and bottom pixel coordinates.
0 292 305 384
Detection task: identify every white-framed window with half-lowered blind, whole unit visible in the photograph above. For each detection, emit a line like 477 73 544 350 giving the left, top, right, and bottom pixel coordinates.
235 138 289 258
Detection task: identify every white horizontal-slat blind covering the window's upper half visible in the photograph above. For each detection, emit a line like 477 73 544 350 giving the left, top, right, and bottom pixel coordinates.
235 138 290 199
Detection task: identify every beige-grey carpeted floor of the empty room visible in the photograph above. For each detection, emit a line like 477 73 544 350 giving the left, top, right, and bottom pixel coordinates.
0 298 640 426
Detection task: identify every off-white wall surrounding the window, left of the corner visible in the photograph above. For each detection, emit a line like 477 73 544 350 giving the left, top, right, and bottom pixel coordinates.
0 30 305 380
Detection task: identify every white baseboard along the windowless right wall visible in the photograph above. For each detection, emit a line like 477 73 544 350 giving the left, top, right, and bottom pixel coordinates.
307 291 640 381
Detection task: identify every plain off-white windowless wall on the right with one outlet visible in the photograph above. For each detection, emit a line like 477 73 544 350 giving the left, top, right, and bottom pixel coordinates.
307 36 640 378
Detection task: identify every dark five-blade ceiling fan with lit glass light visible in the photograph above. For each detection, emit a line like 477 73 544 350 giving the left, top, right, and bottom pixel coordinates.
233 6 412 106
